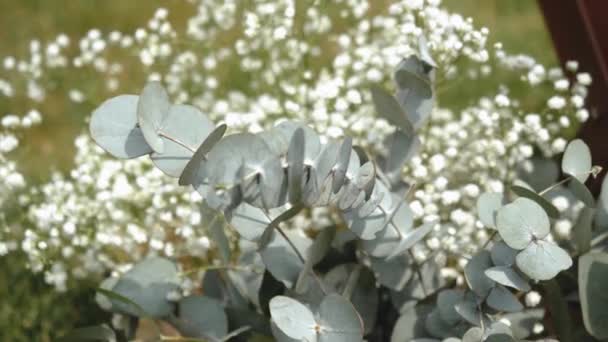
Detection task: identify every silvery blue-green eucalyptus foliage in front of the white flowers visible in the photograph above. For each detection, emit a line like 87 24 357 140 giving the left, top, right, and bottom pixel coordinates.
78 53 608 342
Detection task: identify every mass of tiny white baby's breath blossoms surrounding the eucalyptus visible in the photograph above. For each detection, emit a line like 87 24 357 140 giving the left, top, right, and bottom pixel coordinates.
0 0 590 289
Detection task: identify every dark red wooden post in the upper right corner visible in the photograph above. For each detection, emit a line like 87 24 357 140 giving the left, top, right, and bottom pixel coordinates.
538 0 608 193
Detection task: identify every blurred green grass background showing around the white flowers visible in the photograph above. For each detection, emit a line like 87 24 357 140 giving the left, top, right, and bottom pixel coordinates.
0 0 558 341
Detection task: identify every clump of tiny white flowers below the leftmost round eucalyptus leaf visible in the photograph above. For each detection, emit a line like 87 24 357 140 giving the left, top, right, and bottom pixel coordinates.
11 136 210 289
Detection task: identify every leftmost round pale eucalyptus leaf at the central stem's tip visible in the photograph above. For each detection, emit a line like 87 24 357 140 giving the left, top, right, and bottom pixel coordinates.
89 95 152 159
